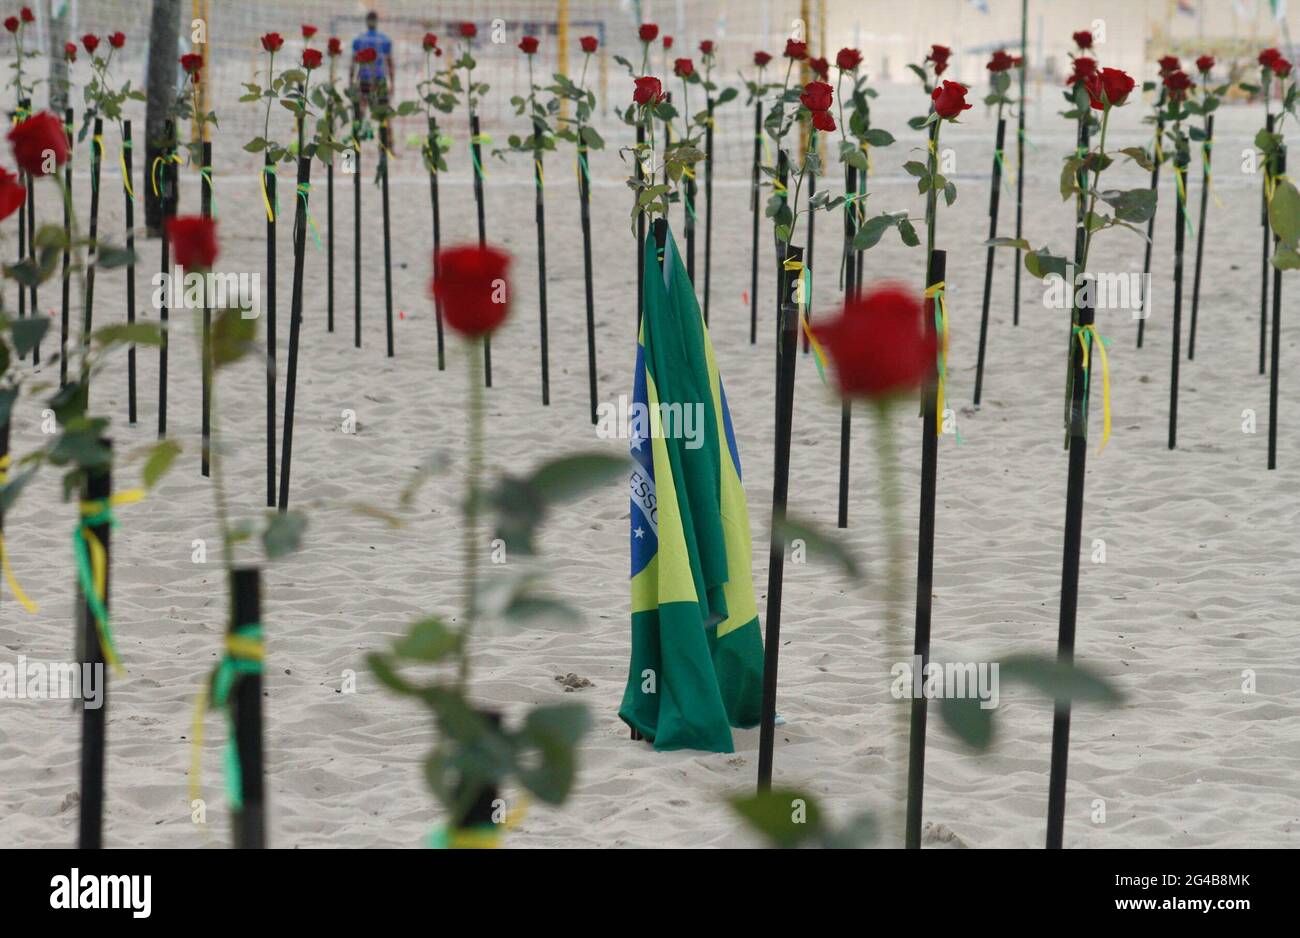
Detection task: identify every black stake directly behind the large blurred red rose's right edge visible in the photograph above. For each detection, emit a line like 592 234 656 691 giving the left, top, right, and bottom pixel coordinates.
905 251 948 850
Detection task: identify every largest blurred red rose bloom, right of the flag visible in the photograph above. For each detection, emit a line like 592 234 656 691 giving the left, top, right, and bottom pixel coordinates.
813 283 939 400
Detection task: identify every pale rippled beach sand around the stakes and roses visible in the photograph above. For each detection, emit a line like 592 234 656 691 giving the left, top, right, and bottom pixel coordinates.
0 84 1300 847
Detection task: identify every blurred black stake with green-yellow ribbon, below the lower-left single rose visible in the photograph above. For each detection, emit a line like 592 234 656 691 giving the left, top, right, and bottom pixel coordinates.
228 566 267 850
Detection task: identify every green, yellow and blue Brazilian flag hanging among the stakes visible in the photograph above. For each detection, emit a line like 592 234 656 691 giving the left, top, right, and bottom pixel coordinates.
619 233 763 752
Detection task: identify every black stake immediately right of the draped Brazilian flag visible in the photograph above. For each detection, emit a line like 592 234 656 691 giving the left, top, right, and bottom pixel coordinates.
758 235 803 791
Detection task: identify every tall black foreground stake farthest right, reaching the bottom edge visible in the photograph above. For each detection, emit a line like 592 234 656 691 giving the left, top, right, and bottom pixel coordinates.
1047 226 1096 850
